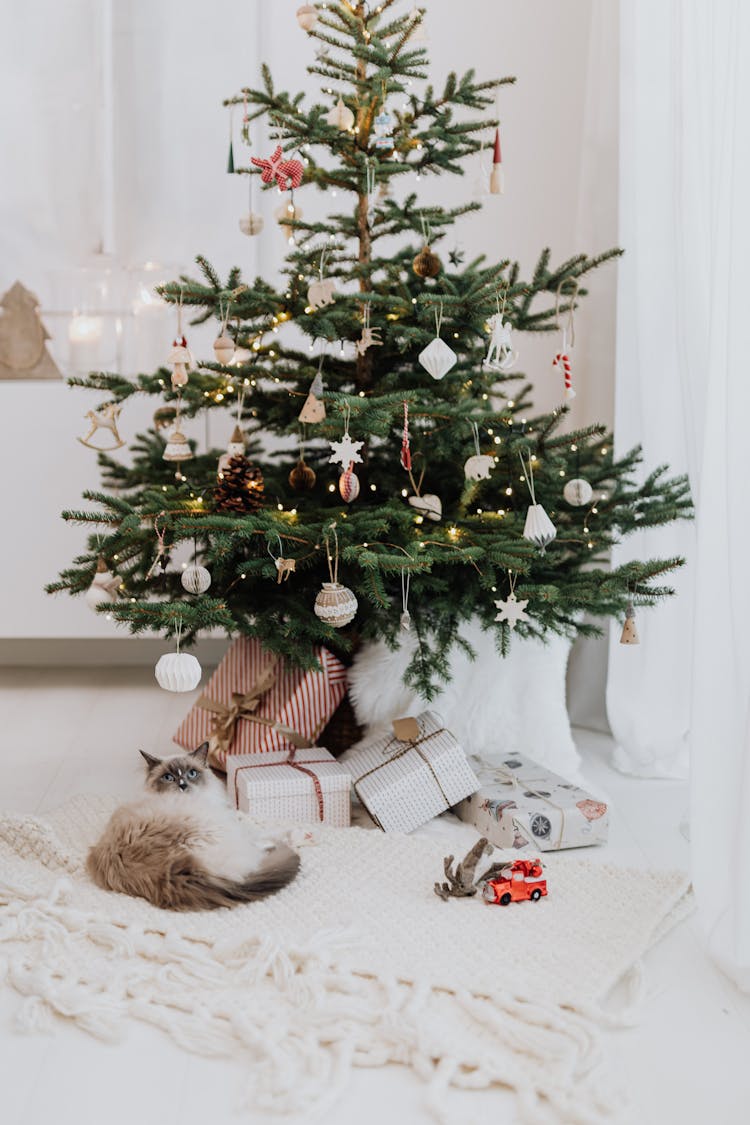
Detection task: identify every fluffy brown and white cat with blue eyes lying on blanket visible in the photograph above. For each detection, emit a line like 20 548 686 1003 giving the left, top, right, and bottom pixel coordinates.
87 743 299 910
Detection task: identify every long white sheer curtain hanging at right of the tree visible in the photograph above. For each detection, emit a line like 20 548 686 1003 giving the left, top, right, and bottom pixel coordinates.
607 0 750 988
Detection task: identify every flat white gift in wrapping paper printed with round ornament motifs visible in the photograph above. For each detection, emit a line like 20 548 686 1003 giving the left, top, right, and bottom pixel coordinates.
454 755 609 852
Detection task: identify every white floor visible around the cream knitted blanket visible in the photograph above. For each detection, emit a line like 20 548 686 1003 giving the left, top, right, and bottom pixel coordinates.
0 668 750 1125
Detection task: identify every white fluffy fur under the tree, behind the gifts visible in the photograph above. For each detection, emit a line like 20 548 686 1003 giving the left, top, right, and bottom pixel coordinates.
349 621 580 776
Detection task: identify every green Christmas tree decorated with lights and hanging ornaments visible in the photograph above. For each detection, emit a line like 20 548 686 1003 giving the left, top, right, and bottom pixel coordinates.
48 0 690 696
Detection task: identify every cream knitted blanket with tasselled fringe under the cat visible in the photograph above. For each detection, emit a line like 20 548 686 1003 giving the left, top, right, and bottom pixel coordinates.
0 798 689 1125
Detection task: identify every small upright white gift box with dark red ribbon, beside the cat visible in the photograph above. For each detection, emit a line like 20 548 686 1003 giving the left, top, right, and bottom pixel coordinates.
227 746 352 828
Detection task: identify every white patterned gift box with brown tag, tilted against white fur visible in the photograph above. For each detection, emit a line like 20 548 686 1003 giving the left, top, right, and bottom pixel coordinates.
338 711 479 833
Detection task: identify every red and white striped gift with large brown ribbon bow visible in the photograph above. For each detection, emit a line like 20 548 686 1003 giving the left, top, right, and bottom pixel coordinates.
174 637 346 770
